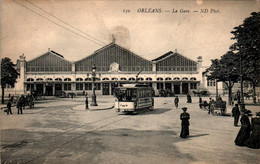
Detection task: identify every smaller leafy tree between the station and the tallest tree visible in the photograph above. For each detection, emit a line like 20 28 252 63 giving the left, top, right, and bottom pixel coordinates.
207 51 239 105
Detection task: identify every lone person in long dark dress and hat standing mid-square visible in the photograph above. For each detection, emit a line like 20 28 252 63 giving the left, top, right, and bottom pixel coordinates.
180 107 190 138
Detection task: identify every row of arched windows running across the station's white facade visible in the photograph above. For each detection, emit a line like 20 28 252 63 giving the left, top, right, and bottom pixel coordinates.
27 77 196 81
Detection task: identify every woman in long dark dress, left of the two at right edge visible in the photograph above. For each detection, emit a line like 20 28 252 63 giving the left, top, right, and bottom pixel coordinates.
235 110 251 146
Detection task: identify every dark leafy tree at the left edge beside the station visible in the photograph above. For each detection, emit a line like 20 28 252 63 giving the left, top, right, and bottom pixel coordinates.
1 58 19 104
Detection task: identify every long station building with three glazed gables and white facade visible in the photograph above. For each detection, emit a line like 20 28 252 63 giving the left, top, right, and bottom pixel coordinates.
9 42 217 96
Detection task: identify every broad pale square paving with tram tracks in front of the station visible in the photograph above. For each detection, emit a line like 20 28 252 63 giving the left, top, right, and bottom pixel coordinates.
0 96 260 164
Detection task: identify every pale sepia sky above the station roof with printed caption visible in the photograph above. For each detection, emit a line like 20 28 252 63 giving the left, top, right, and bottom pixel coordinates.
1 0 260 66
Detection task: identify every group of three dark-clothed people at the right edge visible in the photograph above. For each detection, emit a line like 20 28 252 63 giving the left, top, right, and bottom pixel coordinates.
232 104 260 149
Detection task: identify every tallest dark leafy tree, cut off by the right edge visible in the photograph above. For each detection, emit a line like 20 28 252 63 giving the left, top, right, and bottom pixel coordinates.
231 12 260 103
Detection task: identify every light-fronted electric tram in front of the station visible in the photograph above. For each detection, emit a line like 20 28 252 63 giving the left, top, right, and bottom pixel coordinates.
114 84 154 113
